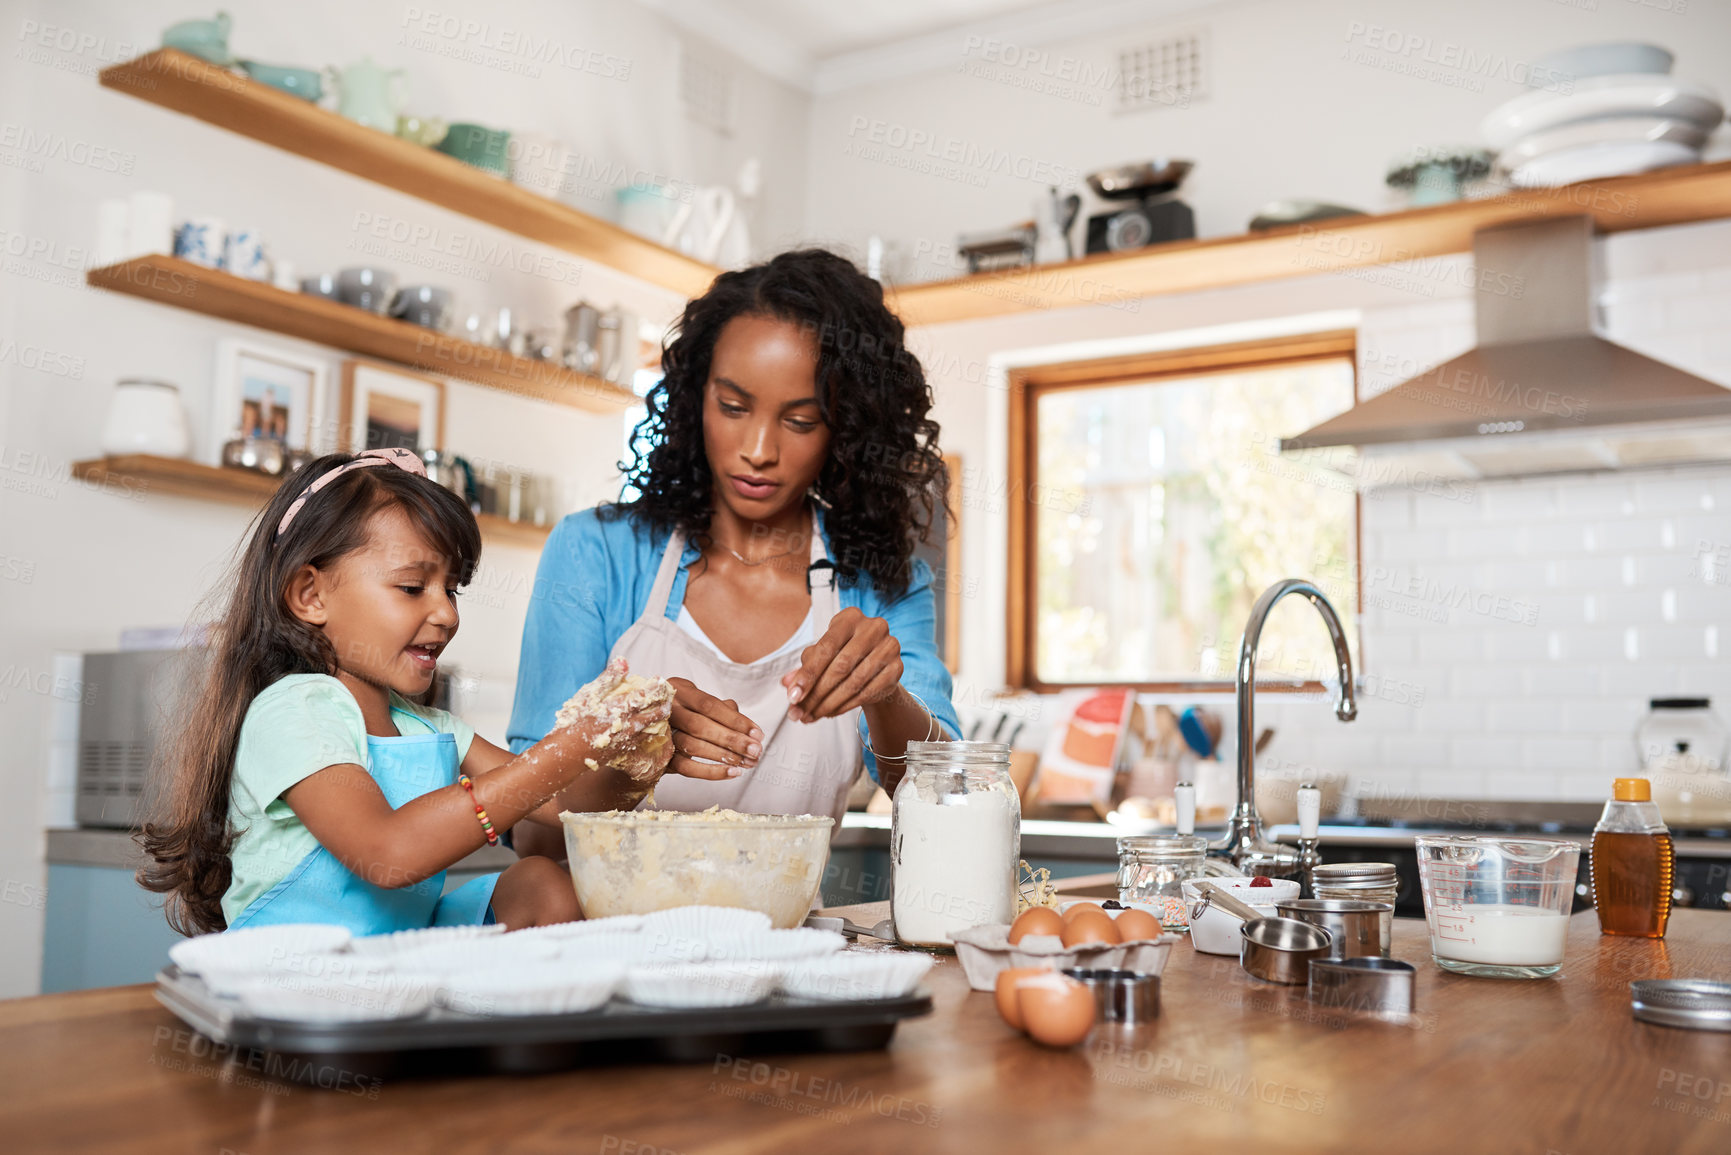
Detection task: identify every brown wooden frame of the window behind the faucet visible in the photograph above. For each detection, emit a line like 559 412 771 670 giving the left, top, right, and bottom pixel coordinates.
1004 329 1364 693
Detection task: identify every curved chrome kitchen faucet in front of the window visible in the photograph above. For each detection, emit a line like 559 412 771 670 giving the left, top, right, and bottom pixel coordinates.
1208 578 1359 876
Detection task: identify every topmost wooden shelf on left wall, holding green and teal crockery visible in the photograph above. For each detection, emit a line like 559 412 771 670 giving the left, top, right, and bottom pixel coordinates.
100 48 720 296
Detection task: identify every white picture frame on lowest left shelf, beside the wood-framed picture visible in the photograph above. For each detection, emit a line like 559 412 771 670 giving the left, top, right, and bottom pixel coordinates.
206 338 331 462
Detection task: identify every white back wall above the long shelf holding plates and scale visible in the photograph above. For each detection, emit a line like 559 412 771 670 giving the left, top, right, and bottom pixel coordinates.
807 0 1731 271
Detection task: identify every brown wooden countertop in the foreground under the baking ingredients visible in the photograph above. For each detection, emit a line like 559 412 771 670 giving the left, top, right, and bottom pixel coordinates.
0 904 1731 1155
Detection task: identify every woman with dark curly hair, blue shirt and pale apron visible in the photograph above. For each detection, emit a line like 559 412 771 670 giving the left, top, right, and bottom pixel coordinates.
509 249 959 841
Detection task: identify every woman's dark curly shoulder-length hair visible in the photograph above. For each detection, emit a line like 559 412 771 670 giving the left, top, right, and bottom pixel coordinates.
602 249 949 594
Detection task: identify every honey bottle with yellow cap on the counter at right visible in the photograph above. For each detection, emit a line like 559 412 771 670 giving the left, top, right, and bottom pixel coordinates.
1589 778 1676 939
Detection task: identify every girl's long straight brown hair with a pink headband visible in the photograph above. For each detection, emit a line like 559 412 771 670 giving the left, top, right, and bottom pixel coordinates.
137 454 481 935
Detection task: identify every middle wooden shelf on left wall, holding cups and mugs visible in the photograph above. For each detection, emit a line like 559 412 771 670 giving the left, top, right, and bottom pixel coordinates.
85 256 637 412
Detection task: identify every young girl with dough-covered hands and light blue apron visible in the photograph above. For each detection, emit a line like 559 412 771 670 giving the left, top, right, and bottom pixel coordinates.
138 448 672 935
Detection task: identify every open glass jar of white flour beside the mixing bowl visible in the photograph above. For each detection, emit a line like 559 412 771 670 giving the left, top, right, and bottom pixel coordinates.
890 741 1021 951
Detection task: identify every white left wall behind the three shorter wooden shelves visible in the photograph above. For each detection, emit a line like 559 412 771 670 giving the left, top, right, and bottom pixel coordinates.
0 0 805 997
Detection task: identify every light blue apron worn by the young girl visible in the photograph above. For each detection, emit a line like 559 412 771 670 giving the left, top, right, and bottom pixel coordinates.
228 730 499 935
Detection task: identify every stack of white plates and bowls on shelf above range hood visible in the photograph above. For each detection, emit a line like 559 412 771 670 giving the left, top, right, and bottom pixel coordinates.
1480 43 1724 187
